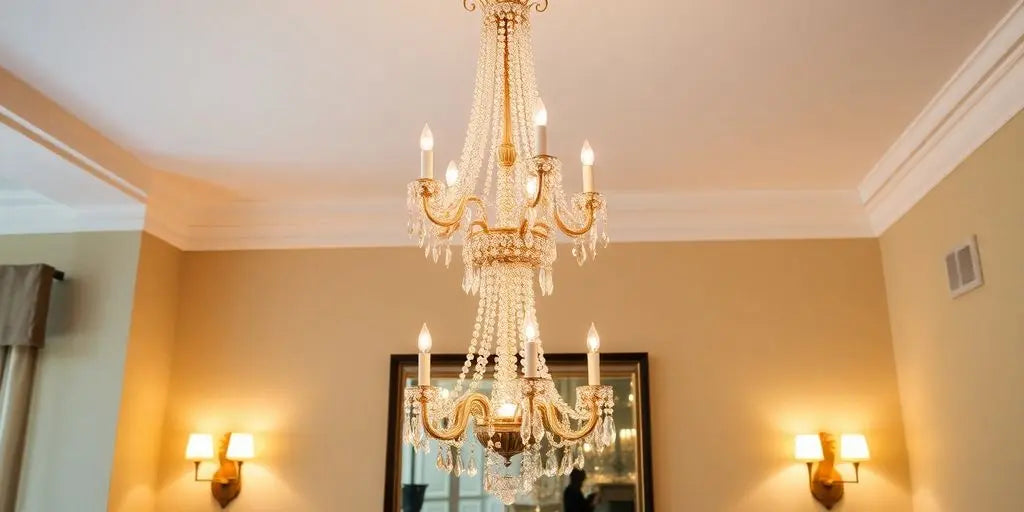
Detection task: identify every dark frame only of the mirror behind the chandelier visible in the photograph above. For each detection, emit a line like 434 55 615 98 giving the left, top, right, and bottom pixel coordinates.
384 352 654 512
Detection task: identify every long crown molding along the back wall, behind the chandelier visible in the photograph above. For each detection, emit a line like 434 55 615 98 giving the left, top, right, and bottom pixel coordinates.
145 189 872 251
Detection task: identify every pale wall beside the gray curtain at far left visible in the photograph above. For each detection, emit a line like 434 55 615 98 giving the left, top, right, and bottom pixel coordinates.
0 231 139 512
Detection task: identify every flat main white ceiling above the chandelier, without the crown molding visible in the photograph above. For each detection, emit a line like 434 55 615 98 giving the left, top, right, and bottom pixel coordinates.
0 0 1014 200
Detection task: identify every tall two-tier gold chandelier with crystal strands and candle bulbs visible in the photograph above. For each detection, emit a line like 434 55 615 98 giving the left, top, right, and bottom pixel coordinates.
402 0 615 505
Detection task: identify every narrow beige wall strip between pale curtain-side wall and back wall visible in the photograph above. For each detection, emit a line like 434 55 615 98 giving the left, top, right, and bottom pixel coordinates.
108 233 181 512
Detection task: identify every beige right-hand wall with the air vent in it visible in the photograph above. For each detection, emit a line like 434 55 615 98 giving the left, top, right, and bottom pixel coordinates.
882 114 1024 512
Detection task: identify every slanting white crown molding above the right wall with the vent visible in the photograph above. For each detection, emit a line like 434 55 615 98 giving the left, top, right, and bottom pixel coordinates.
858 0 1024 236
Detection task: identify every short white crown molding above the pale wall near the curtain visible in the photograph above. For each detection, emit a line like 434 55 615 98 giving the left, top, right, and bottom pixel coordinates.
0 203 145 234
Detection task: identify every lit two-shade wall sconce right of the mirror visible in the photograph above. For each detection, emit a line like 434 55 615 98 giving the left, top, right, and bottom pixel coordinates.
796 432 870 510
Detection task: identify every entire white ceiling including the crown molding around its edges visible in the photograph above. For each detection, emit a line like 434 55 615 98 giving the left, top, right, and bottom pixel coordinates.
0 0 1024 250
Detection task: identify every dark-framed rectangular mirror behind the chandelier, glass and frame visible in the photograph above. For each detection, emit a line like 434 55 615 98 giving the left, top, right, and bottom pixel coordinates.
384 353 654 512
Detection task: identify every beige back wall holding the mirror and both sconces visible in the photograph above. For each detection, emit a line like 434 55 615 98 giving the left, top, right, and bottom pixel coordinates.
158 240 910 512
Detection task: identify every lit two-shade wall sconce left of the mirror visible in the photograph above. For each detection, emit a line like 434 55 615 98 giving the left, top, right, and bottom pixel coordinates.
185 432 255 508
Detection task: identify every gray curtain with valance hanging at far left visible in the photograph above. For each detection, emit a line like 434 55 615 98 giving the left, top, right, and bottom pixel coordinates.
0 264 55 512
